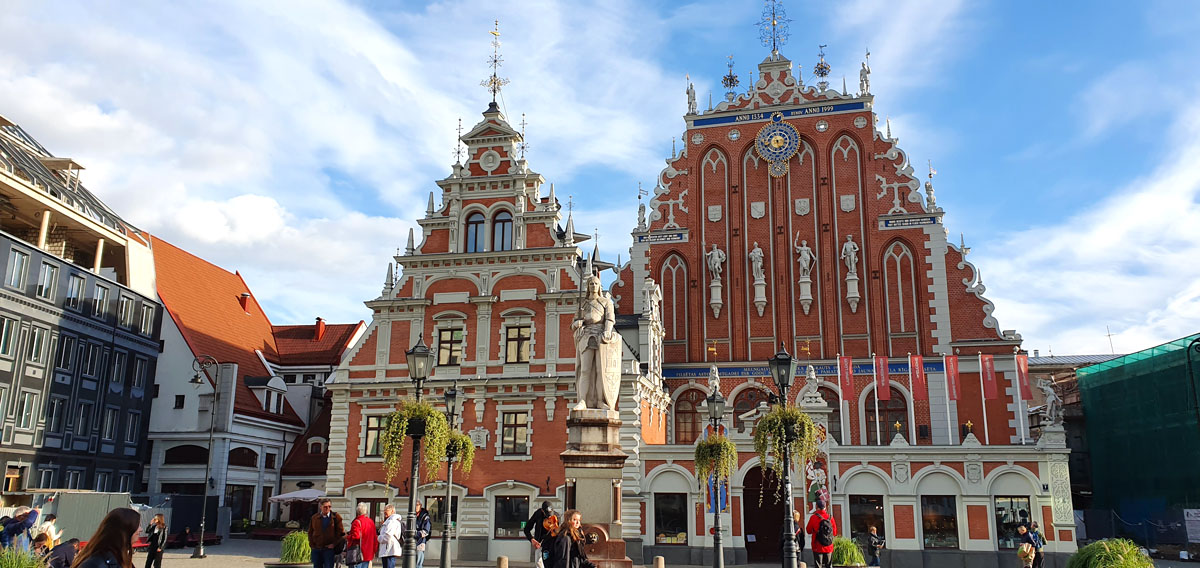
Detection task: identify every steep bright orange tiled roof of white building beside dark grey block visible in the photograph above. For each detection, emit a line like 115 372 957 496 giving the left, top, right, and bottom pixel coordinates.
151 238 304 426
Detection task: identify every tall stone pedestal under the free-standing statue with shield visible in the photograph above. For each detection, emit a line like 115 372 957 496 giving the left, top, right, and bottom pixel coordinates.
559 409 634 568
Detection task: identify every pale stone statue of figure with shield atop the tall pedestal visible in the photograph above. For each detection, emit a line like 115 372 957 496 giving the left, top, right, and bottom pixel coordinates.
571 275 620 411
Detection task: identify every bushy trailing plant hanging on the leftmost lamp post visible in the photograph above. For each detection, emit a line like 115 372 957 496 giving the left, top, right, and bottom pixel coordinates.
379 400 450 485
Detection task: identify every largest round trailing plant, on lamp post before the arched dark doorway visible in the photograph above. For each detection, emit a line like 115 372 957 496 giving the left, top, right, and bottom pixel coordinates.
754 405 817 500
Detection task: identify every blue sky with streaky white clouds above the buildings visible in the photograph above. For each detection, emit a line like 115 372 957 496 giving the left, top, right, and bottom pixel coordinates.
0 0 1200 354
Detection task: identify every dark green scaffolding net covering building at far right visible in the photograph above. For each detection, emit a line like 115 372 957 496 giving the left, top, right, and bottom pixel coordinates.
1076 334 1200 509
